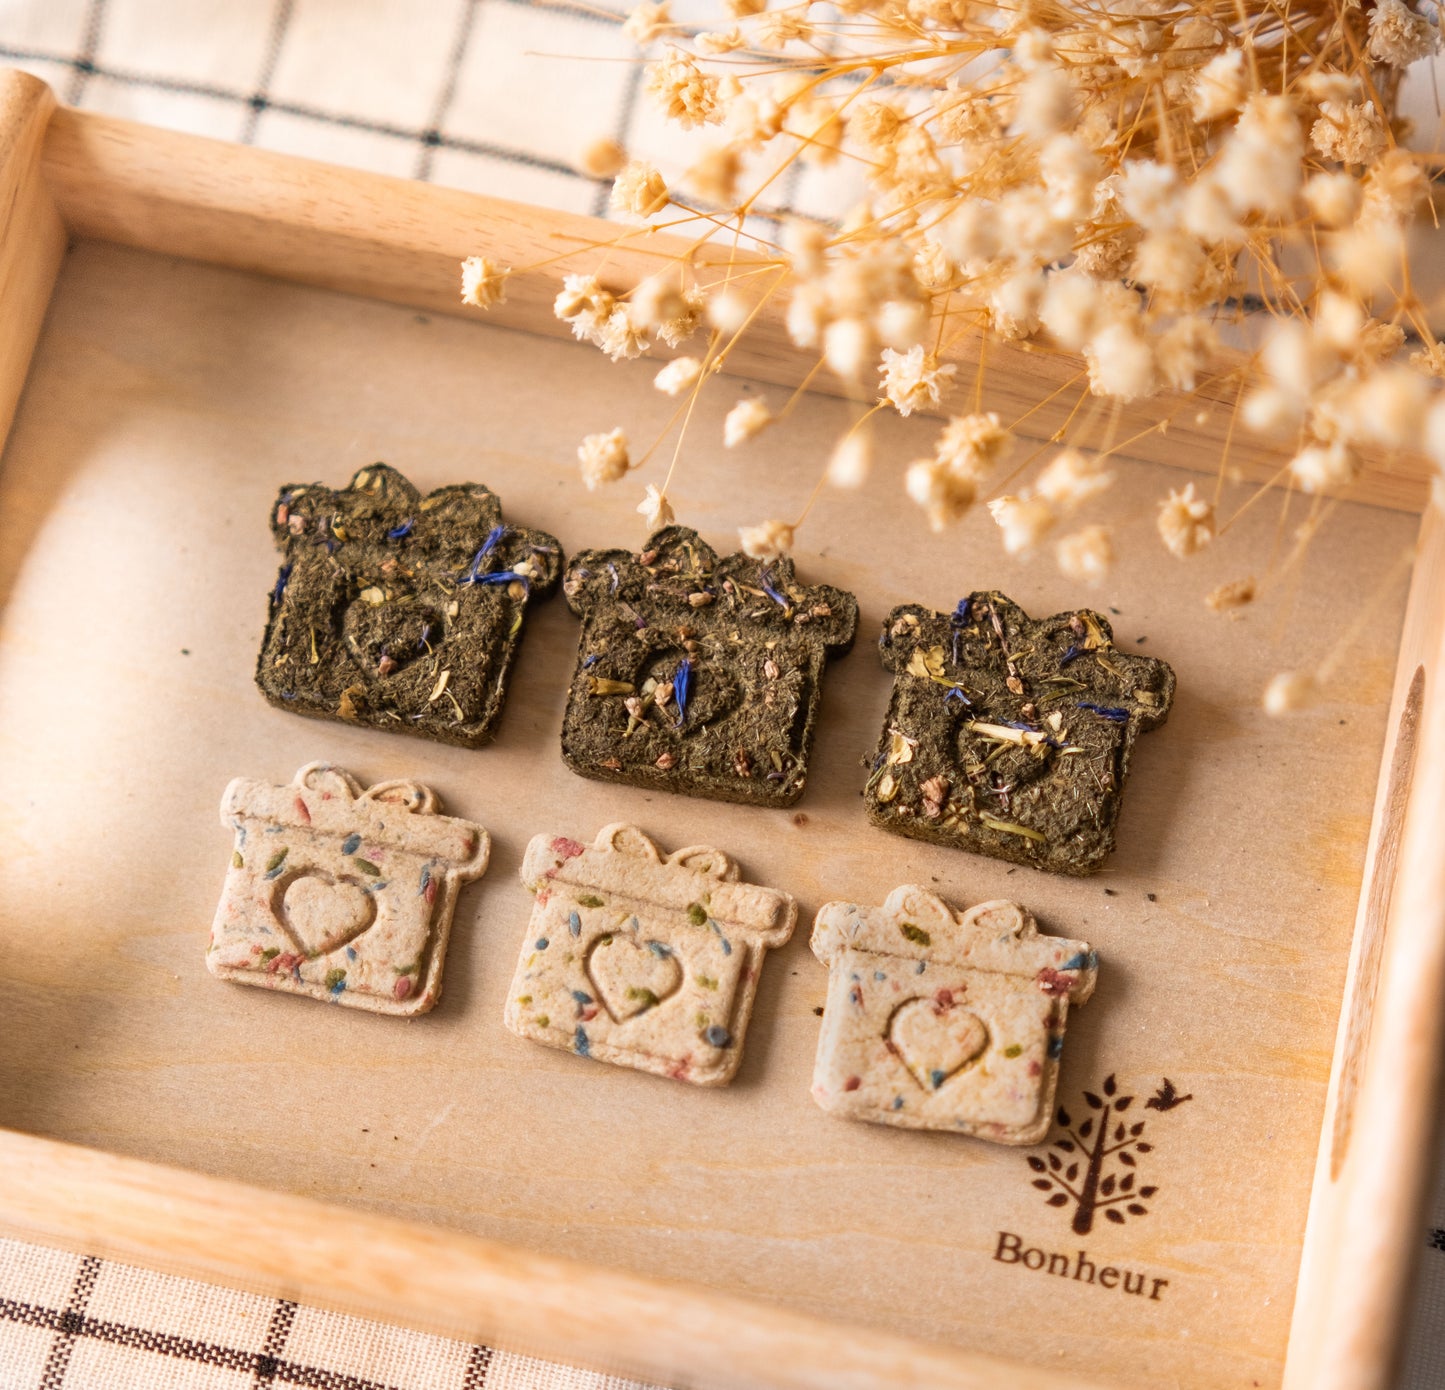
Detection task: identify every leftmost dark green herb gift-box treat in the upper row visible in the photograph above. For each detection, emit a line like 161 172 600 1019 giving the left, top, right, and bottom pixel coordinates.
256 464 562 748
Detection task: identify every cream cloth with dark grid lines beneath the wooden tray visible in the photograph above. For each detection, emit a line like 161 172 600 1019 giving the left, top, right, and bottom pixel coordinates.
0 0 1445 1390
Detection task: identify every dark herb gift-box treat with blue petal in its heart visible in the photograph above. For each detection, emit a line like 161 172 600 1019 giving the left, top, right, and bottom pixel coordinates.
562 526 858 806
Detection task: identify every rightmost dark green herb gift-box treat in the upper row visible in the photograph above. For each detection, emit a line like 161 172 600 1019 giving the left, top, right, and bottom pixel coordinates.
864 592 1175 874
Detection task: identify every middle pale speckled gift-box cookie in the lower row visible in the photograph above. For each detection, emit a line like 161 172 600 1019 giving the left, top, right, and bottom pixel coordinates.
506 824 798 1087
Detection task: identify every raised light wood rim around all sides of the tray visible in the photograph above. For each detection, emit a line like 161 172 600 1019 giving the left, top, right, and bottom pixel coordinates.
0 71 1445 1390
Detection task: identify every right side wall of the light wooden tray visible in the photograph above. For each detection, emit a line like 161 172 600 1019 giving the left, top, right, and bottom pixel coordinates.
1286 507 1445 1390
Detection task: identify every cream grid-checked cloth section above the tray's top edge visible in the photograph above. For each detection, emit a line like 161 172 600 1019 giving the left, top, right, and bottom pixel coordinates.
0 0 847 221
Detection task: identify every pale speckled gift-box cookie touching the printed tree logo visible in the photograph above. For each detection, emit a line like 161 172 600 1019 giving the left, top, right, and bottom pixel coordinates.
812 884 1098 1144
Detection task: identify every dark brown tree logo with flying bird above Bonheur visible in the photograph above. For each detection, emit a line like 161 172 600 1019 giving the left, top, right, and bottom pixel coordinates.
1029 1074 1194 1235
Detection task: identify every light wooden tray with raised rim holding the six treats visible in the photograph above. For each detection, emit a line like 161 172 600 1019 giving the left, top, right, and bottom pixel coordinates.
0 74 1445 1390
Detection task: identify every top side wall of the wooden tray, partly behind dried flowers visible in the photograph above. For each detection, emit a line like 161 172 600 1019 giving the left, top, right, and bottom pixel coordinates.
36 96 1429 511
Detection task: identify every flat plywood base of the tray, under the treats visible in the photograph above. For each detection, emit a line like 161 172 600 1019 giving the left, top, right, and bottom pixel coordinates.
0 241 1410 1390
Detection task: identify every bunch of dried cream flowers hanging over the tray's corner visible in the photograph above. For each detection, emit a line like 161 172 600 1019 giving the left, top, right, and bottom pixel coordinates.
464 0 1445 612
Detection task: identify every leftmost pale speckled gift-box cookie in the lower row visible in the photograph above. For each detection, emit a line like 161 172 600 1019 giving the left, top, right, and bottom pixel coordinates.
205 763 491 1014
